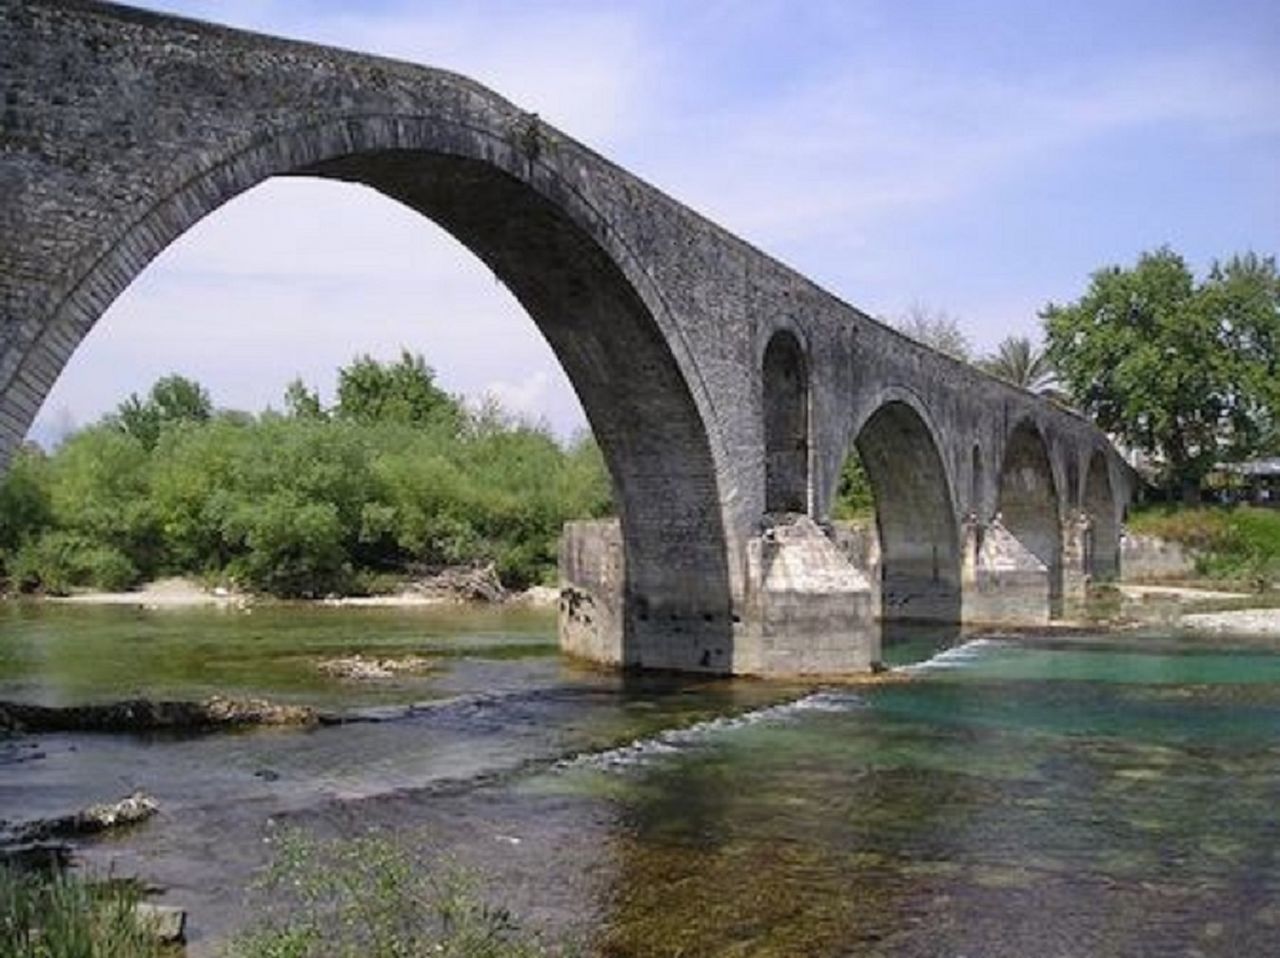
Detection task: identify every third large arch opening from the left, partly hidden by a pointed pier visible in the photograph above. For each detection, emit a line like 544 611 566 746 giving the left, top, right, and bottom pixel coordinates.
988 418 1064 619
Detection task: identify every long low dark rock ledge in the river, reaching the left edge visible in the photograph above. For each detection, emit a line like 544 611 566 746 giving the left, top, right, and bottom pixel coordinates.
0 695 320 733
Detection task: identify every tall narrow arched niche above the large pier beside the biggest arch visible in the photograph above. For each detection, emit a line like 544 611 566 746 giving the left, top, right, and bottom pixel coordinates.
760 329 809 514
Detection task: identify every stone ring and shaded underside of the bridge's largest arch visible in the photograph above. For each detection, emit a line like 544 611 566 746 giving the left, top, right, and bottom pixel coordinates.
0 123 732 671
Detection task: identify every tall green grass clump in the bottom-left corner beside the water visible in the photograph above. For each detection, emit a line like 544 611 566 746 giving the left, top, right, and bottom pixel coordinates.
0 866 166 958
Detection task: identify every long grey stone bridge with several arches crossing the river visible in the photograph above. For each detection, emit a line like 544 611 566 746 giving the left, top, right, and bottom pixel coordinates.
0 0 1134 674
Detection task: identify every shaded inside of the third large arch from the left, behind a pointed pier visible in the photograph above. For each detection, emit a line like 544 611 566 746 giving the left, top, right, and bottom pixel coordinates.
996 420 1062 616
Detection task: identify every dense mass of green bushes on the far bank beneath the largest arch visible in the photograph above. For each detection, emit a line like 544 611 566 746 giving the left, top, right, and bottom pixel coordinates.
0 355 612 597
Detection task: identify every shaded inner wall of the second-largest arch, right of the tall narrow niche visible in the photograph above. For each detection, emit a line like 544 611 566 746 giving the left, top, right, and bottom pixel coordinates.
854 401 961 639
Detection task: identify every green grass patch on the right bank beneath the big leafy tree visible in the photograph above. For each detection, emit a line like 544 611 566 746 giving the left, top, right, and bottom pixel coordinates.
1129 506 1280 590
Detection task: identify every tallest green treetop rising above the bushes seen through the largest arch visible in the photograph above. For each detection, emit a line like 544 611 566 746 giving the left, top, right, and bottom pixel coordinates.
335 350 461 426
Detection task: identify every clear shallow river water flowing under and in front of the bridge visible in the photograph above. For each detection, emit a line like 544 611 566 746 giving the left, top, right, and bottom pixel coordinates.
0 606 1280 958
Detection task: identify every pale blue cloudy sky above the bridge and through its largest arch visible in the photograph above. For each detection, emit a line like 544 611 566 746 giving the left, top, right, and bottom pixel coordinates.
22 0 1280 443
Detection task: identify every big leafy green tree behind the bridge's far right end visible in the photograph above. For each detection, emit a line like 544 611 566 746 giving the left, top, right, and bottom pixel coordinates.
1041 247 1280 501
